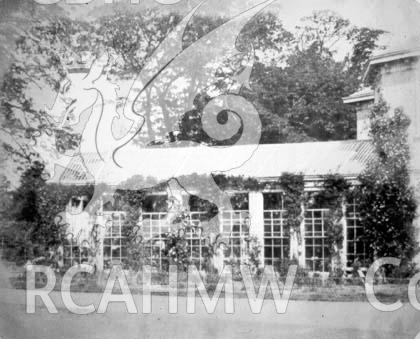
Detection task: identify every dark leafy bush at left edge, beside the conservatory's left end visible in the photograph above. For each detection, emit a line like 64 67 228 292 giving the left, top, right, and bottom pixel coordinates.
1 162 93 262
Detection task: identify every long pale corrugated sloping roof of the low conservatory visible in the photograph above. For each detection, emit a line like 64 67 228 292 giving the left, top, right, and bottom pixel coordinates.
55 140 374 185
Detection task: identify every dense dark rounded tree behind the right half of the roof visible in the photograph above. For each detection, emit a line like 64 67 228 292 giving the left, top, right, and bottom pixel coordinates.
252 43 356 143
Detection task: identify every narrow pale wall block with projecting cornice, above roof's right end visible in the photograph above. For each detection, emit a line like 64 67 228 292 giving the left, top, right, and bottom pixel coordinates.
343 87 375 140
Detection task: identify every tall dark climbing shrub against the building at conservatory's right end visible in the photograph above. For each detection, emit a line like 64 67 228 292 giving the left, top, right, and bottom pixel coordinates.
356 102 417 265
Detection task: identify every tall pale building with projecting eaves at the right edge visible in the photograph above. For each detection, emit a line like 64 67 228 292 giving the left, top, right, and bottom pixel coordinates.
344 38 420 263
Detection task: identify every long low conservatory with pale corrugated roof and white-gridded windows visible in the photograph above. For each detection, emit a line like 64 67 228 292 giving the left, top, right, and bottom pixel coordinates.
56 140 374 272
